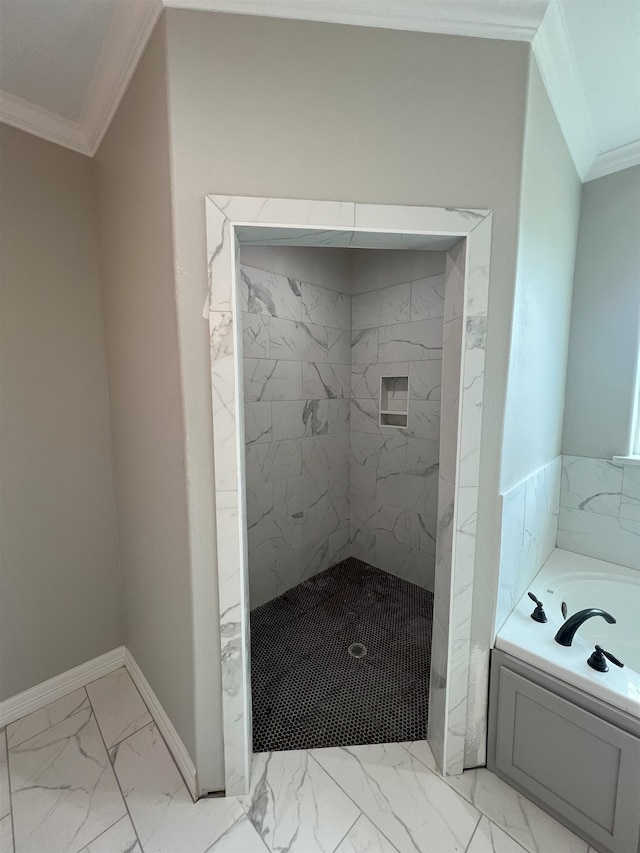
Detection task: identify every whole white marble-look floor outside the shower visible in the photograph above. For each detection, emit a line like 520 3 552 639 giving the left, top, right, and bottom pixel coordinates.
0 669 592 853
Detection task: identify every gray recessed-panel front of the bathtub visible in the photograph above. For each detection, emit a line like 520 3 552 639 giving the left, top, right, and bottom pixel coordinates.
487 650 640 853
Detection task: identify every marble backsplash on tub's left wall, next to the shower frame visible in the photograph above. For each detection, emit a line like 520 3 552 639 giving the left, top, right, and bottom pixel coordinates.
495 456 562 631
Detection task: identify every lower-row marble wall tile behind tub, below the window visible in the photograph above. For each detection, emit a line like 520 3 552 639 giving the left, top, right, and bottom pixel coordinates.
558 506 640 570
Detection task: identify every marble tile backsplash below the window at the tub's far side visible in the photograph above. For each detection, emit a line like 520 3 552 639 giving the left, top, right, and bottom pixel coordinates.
558 456 640 571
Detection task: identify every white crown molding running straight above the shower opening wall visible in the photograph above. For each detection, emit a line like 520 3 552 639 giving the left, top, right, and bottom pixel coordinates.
164 0 549 42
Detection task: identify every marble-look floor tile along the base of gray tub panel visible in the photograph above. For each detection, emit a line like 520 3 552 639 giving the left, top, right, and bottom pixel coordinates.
409 743 588 853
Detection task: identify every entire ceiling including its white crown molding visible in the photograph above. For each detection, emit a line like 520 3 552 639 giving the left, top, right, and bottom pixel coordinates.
0 0 640 180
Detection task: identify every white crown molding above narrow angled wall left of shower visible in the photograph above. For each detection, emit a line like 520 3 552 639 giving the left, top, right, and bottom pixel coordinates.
79 0 163 157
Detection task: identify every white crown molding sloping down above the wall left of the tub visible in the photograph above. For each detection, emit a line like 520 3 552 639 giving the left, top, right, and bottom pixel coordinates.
533 2 598 181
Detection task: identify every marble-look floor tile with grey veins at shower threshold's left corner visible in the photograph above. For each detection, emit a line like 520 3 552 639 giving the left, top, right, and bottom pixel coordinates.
245 750 360 853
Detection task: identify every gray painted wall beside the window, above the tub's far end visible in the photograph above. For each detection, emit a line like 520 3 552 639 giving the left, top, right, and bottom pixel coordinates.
562 166 640 459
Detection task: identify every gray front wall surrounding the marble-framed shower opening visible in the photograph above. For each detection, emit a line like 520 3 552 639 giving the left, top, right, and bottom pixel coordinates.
165 9 530 778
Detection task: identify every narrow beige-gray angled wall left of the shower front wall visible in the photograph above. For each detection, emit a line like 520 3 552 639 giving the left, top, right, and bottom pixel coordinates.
95 22 198 755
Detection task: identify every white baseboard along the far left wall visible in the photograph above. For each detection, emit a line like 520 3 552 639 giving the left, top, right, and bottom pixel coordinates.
0 646 125 726
